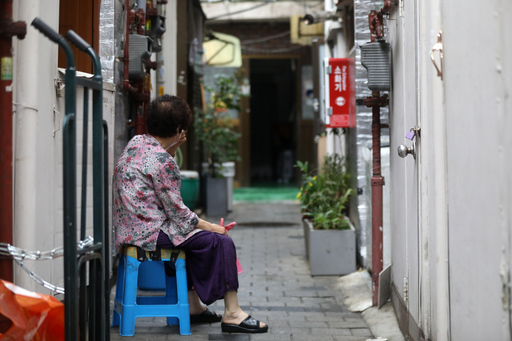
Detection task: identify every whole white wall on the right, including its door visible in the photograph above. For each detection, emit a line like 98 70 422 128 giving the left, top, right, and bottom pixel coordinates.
386 0 512 340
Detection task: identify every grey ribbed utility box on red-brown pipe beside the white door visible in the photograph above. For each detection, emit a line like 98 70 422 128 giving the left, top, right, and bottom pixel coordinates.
361 41 391 91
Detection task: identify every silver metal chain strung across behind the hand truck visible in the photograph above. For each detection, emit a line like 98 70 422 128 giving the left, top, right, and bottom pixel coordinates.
0 236 94 294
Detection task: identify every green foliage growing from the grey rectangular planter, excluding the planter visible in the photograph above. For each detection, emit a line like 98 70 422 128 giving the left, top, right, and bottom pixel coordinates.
296 154 352 230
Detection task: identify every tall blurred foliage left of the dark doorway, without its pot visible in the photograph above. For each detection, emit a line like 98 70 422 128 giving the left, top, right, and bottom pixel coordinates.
194 74 242 177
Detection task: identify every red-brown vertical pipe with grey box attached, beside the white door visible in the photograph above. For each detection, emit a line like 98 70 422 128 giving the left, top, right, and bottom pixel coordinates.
361 0 391 306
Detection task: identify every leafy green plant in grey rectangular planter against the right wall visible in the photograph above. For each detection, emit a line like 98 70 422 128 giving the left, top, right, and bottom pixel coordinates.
296 154 356 275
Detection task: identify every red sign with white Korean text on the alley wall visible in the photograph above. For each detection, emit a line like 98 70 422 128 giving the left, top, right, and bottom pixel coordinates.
326 58 356 128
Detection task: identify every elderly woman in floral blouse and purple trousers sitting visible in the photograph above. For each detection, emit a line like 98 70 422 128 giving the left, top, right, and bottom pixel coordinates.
113 95 268 333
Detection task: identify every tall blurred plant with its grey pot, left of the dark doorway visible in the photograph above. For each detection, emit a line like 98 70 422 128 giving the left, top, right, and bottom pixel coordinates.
194 75 241 216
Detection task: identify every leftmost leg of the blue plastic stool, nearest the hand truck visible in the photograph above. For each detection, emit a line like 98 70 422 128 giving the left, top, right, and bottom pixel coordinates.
119 256 140 336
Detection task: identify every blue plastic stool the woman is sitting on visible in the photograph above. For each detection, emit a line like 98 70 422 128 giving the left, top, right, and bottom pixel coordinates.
112 246 191 336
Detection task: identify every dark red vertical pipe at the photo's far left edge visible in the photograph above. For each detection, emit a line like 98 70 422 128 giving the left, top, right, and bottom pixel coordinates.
0 0 27 282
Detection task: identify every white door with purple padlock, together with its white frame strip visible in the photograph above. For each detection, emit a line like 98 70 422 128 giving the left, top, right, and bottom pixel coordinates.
388 0 448 340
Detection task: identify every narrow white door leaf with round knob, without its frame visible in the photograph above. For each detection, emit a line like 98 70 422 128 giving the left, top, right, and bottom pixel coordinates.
386 0 421 332
